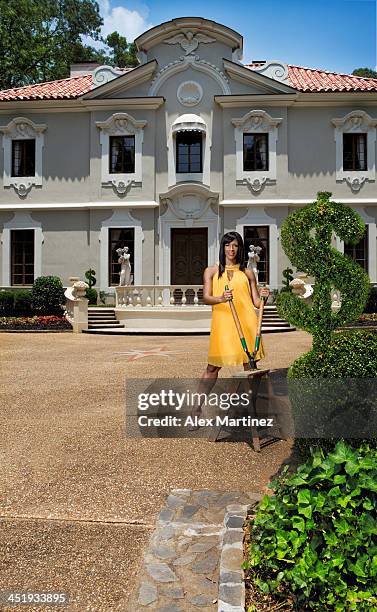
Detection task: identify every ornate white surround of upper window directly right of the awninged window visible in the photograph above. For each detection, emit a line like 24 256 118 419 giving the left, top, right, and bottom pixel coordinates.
232 110 283 192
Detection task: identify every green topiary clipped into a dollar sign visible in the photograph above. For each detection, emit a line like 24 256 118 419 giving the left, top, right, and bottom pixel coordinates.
277 192 369 353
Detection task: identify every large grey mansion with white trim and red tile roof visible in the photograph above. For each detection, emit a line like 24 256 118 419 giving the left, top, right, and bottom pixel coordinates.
0 17 377 293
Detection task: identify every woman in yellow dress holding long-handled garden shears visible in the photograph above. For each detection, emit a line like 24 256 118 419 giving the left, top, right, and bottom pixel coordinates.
203 232 269 379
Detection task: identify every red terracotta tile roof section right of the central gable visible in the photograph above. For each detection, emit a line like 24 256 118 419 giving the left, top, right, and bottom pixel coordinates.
247 62 377 92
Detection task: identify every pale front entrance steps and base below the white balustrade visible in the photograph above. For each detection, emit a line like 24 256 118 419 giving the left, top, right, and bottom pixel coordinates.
83 306 296 335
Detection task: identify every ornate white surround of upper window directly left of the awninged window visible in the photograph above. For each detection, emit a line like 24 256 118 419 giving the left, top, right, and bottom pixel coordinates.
96 113 147 196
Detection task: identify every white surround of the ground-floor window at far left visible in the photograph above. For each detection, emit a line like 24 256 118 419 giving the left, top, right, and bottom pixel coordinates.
1 212 44 287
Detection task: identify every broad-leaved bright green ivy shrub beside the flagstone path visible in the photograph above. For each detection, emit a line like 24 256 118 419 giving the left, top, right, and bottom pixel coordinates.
246 442 377 612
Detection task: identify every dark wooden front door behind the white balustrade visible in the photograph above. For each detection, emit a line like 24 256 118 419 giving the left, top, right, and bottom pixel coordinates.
170 227 208 303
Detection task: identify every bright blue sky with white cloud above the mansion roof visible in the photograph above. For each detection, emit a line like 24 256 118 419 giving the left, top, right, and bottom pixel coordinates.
98 0 377 73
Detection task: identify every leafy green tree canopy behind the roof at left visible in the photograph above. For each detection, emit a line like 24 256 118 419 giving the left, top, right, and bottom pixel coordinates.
0 0 137 89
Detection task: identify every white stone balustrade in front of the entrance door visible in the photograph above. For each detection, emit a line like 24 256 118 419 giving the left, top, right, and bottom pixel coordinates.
115 285 204 308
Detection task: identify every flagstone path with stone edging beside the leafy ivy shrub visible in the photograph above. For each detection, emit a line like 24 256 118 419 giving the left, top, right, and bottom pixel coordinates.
128 489 262 612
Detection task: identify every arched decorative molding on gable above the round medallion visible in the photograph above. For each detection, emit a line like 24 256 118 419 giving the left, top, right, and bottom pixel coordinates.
148 55 231 96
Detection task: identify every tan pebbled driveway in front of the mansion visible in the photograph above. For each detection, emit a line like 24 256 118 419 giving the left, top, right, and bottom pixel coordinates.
0 332 311 612
